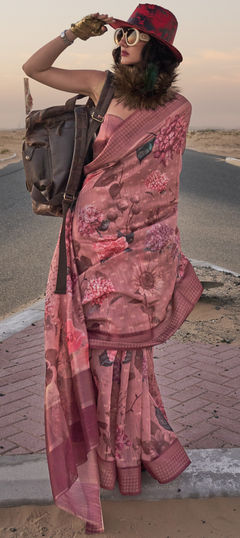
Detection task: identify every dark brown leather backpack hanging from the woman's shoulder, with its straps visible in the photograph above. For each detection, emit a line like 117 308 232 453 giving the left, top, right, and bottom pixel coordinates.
22 71 114 293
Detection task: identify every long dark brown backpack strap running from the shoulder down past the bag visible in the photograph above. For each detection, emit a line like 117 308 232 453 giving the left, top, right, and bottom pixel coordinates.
55 71 114 294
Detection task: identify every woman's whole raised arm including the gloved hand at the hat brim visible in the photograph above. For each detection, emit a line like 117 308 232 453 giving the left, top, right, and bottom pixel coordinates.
22 13 113 102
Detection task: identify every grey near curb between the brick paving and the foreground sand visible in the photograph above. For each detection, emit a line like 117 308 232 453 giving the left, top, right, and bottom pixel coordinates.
0 448 240 507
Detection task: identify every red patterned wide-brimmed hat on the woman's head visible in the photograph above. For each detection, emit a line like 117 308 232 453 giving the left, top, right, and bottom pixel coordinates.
110 4 183 62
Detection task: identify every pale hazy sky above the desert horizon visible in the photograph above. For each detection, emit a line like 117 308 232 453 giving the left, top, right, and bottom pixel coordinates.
0 0 240 128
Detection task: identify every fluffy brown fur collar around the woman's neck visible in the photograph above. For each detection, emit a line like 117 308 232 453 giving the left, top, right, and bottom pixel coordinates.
113 64 178 110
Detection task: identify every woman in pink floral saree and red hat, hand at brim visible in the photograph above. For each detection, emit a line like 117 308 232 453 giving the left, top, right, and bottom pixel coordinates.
23 4 202 533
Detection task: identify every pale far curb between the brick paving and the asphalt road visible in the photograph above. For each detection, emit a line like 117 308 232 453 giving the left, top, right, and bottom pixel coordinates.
0 258 240 341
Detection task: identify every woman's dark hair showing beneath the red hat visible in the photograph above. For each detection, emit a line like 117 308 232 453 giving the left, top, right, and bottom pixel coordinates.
112 37 179 75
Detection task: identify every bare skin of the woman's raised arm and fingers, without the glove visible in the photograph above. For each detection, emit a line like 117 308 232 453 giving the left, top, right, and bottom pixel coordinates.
22 14 112 102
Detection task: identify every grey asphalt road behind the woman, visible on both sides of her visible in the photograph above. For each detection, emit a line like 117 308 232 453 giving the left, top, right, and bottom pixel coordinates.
0 150 240 316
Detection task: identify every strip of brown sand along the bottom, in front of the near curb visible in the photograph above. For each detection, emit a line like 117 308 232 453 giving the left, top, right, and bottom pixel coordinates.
0 497 240 538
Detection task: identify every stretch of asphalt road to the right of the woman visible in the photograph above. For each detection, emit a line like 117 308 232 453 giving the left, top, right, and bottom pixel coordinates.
178 150 240 273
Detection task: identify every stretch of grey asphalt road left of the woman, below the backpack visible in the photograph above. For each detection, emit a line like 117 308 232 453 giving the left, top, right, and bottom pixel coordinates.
0 162 61 316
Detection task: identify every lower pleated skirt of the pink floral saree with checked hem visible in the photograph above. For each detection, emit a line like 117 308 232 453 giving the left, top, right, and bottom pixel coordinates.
90 348 190 495
